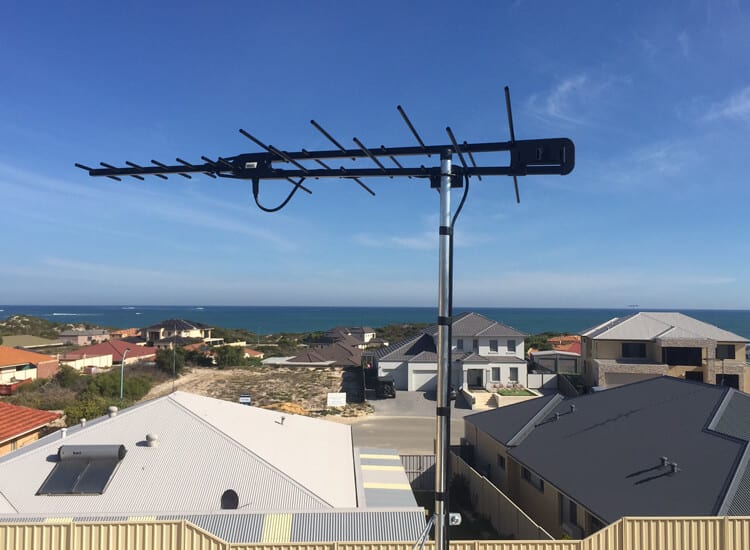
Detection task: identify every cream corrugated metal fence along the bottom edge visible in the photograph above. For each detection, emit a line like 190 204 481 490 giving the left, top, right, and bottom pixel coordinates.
0 516 750 550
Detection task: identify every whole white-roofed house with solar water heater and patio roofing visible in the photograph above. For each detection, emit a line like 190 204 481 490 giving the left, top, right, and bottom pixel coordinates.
0 391 426 544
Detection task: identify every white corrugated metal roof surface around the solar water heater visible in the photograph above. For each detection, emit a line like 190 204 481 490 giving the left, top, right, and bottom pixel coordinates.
0 392 356 514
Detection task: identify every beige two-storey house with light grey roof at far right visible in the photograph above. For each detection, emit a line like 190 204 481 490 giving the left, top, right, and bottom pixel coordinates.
581 312 750 392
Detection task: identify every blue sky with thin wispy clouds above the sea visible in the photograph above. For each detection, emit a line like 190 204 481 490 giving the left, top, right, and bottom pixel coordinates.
0 0 750 309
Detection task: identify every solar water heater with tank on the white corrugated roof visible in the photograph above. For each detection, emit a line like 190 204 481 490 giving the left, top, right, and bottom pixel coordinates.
36 445 127 495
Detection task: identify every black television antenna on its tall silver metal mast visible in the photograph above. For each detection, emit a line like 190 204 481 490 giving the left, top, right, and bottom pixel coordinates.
76 87 575 550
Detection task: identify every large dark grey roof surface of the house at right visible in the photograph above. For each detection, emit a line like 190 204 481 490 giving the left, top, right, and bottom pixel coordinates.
466 377 750 522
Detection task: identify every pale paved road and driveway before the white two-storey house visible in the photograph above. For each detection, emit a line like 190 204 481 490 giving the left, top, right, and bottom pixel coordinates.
352 391 472 454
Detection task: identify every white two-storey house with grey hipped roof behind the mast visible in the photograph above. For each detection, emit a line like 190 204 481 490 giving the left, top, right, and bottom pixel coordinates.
372 312 527 391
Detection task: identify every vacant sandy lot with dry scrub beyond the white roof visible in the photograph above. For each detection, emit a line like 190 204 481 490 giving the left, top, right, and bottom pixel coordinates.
144 367 369 416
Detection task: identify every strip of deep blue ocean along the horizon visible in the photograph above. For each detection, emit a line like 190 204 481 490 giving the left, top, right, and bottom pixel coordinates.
0 305 750 338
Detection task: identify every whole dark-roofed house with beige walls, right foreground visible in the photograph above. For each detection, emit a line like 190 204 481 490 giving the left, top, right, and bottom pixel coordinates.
464 376 750 538
